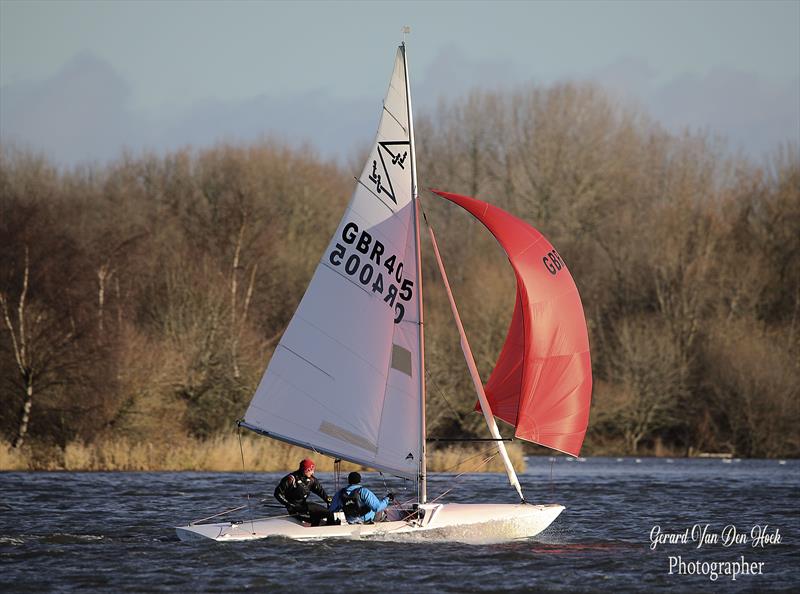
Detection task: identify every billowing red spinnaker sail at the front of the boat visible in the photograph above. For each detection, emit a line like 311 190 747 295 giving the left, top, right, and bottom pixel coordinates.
433 190 592 456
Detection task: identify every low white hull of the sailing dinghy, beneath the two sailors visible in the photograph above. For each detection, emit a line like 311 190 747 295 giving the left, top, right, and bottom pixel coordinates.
175 503 564 542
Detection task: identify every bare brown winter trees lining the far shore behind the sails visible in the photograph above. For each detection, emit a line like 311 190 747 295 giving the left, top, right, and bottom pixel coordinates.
0 84 800 456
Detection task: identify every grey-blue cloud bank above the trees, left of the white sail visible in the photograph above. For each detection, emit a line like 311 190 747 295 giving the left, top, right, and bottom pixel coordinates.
0 53 381 167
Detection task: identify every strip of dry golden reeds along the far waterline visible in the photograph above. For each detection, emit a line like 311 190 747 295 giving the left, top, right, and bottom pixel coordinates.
0 435 525 472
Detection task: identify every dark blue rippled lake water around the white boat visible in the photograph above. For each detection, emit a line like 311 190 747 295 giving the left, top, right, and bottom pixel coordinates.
0 458 800 592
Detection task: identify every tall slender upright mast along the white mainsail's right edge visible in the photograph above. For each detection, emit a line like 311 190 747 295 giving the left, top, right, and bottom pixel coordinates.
400 41 428 503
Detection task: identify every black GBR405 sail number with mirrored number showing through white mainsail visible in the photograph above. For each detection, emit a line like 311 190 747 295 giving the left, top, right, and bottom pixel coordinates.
328 221 414 324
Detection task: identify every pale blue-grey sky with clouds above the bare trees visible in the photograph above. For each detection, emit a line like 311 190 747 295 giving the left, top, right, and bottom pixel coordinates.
0 0 800 165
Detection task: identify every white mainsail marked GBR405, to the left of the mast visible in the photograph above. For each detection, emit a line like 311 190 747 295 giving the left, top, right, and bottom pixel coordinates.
242 46 424 478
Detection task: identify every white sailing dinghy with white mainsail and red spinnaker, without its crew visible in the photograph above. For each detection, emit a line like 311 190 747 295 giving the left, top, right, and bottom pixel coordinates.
176 43 592 541
